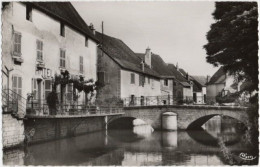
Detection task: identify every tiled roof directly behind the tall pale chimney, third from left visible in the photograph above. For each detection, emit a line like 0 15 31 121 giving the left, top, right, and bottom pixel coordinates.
136 53 175 78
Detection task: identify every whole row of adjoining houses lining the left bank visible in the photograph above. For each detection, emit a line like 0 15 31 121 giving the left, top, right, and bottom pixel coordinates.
2 2 244 115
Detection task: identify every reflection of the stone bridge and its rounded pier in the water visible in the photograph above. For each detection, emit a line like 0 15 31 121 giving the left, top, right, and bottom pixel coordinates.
108 130 247 155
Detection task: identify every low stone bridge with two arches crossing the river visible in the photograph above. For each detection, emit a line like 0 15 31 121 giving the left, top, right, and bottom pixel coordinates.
108 105 248 130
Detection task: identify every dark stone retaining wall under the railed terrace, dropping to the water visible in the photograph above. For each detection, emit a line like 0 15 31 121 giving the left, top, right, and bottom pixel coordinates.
25 117 105 143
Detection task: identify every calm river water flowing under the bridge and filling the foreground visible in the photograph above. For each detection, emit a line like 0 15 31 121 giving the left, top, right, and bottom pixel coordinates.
3 118 256 166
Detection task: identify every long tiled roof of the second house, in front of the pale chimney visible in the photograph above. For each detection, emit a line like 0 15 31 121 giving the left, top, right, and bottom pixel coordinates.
96 32 160 78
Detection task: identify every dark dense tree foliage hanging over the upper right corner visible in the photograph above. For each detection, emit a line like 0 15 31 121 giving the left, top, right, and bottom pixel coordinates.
204 2 258 91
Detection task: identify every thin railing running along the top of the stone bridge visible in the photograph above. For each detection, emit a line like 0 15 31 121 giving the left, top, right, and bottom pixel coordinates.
123 95 225 107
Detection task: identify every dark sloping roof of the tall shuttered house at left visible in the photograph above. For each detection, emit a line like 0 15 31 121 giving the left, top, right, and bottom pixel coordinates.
23 2 98 42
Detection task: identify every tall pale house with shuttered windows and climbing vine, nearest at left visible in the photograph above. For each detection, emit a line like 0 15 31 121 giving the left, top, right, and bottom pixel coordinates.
2 2 98 114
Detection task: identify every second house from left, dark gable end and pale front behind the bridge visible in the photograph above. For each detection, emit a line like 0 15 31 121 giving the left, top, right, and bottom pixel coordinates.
96 32 161 106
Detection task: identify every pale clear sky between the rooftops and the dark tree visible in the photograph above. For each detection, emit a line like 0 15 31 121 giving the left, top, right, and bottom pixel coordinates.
72 1 218 76
